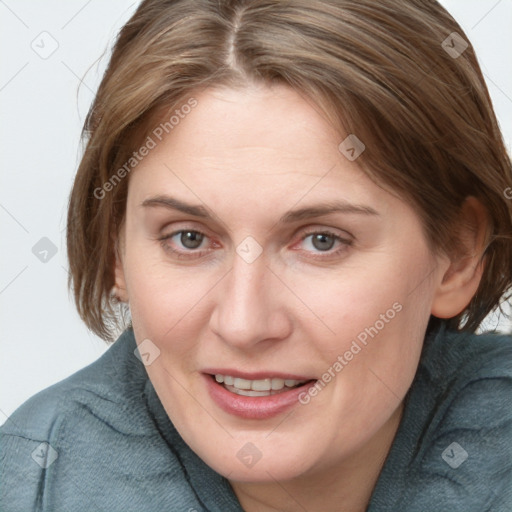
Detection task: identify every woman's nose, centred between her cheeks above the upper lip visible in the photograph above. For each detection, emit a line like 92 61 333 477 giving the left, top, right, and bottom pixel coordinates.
210 250 292 349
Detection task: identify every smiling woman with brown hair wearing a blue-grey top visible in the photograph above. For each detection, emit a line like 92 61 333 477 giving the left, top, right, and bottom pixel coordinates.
1 0 512 512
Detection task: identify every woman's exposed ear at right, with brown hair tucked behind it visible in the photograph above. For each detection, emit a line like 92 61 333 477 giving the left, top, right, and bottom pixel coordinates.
432 197 489 318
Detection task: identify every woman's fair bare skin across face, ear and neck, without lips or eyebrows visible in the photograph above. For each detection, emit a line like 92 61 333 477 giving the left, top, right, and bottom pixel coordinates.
116 85 485 512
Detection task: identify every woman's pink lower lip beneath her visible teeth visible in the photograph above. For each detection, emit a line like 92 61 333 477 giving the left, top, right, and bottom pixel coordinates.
203 374 315 420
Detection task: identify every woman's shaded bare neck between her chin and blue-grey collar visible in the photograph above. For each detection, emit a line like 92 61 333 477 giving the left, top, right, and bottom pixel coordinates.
230 404 403 512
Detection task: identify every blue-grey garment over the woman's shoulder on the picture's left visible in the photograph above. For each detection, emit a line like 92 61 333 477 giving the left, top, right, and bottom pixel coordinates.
0 330 208 511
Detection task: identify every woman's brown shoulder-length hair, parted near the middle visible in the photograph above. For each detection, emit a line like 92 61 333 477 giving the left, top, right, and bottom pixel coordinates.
67 0 512 340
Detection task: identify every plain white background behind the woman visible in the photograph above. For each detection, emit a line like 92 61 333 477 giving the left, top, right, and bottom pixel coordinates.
0 0 512 423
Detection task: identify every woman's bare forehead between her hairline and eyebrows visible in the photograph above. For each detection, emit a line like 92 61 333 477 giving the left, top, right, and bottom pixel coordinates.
129 86 387 216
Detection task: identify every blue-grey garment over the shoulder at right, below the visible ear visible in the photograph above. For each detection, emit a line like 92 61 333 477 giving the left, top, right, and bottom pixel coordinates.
369 324 512 512
